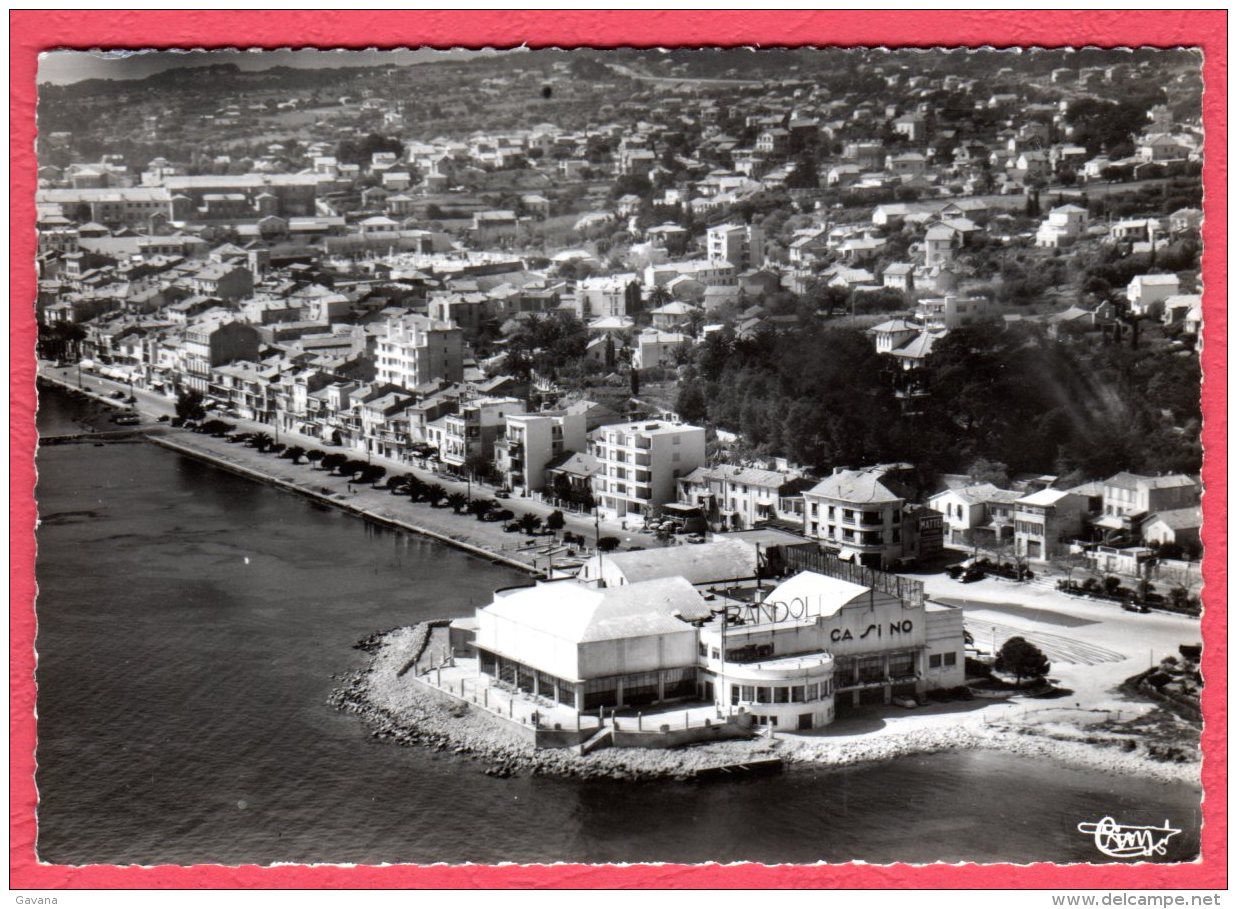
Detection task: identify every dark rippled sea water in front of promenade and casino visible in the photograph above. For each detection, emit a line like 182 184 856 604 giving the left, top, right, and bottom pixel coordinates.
37 392 1199 864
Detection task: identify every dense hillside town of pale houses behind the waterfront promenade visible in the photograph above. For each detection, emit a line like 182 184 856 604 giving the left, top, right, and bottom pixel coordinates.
36 44 1202 583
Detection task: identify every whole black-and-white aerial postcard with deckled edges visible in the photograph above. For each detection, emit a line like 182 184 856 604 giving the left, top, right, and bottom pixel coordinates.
31 47 1207 866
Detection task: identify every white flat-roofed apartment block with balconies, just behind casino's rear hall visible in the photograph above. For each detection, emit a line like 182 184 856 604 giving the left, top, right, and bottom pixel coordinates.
589 420 705 522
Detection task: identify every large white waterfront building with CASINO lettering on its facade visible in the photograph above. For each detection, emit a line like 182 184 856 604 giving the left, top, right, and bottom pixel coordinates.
474 569 964 731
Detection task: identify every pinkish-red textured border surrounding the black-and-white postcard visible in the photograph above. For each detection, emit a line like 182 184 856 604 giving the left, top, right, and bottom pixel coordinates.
9 10 1228 888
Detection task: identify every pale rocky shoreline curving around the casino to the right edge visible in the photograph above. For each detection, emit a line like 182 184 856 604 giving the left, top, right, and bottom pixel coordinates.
329 626 1199 784
